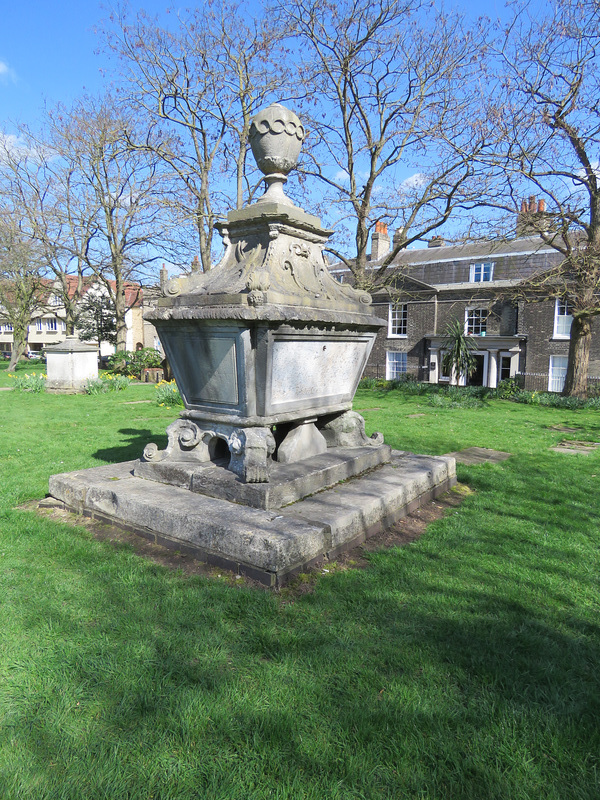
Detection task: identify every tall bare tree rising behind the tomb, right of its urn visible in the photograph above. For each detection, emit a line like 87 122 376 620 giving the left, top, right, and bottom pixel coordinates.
277 0 483 289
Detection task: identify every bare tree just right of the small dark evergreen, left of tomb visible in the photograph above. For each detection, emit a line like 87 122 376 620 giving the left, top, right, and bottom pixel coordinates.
48 97 169 350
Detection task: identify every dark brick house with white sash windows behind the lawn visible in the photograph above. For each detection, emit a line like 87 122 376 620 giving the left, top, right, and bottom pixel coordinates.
330 219 600 392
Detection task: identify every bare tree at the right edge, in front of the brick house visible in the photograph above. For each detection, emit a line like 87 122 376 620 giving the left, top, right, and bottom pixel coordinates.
486 0 600 397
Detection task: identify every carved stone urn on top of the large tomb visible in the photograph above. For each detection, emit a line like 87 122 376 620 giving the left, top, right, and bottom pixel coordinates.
249 103 306 205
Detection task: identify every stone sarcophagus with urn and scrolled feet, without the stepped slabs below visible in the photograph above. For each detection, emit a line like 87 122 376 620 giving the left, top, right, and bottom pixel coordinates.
136 104 389 483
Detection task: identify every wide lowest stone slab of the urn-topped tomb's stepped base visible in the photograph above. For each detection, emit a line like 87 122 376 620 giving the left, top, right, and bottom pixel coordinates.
50 451 456 586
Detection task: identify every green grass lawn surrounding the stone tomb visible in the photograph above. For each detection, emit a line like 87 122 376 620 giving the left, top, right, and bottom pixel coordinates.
0 369 600 800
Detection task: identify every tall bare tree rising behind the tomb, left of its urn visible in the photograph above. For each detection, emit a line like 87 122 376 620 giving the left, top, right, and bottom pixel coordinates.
105 0 286 270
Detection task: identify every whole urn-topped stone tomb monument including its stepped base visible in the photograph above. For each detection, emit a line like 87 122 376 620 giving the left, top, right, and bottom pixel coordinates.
50 104 455 584
